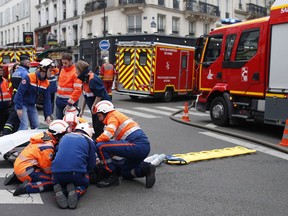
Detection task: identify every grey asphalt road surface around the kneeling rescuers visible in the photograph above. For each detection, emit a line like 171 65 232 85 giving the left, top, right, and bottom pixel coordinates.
0 95 288 216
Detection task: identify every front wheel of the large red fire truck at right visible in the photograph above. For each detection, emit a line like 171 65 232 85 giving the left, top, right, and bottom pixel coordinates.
210 97 229 126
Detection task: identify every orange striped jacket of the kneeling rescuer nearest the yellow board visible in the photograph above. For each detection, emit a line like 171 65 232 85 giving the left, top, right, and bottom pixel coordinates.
96 110 140 142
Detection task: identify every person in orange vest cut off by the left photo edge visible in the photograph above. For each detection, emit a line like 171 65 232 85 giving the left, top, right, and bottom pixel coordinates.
0 65 11 134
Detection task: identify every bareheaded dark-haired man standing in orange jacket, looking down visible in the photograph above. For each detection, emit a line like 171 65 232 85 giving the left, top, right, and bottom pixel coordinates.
56 53 82 119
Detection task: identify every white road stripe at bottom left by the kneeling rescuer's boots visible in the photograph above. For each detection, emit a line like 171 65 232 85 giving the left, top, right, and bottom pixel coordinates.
0 190 44 204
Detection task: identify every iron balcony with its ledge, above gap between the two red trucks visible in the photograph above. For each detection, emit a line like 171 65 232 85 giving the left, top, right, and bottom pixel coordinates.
186 0 220 20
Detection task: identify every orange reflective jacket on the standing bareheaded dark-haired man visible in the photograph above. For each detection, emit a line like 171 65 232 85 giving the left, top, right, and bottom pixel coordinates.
57 65 82 105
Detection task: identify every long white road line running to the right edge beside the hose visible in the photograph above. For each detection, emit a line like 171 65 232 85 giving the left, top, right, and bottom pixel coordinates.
199 132 288 160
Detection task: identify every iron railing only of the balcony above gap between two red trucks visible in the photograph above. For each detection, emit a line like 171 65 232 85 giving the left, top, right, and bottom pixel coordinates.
186 0 220 17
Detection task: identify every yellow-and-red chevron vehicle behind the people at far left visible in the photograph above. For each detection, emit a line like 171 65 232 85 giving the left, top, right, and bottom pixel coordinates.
0 46 36 64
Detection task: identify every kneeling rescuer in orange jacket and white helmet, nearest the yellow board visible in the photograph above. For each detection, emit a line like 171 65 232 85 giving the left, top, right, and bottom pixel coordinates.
95 100 156 188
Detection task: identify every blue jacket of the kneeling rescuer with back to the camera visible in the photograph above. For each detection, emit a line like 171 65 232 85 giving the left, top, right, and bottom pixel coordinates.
52 133 96 173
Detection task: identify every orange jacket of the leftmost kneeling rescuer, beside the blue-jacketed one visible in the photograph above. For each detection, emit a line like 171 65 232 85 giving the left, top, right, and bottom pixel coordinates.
14 132 57 181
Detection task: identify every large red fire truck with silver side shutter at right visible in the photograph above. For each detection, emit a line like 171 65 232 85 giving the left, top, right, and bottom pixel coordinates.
196 0 288 126
